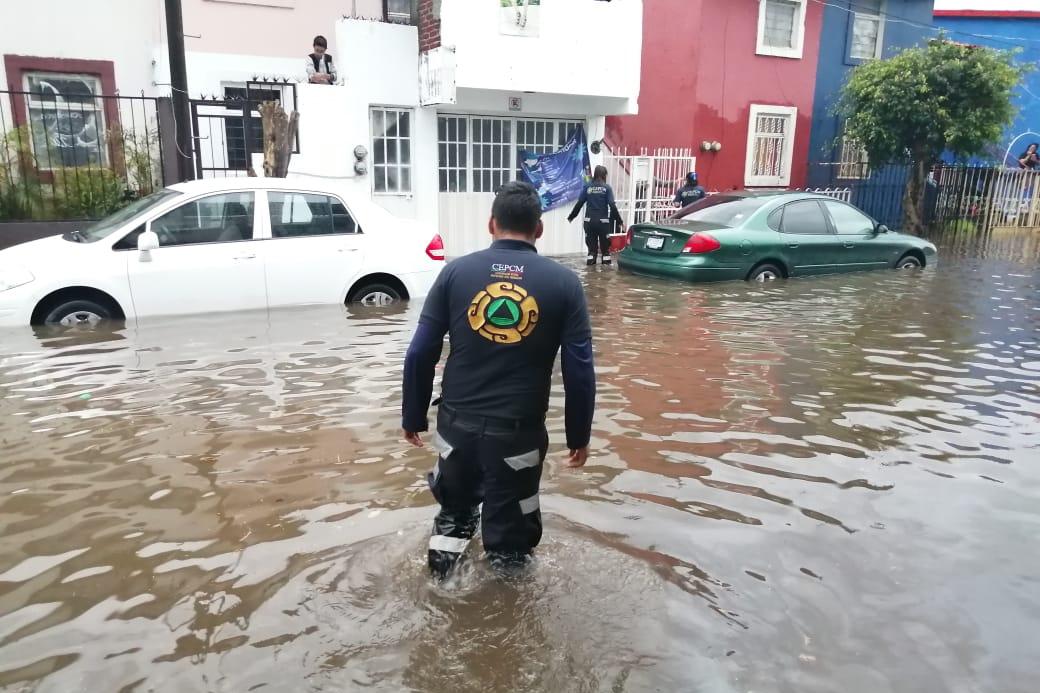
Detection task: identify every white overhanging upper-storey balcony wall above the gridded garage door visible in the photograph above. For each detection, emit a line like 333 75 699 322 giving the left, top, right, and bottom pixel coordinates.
441 0 644 106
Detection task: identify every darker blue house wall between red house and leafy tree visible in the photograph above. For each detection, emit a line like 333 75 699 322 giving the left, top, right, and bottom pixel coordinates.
808 0 935 187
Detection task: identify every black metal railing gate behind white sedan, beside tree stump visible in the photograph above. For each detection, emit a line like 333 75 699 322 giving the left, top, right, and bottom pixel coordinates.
190 79 300 178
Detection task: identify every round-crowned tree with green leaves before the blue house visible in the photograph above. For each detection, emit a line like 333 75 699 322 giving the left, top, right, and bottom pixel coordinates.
838 35 1029 233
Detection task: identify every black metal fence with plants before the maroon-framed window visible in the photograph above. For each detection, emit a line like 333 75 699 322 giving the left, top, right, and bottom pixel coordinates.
0 88 174 222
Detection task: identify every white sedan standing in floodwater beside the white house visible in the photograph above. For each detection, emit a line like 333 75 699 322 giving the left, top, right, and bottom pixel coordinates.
0 178 444 327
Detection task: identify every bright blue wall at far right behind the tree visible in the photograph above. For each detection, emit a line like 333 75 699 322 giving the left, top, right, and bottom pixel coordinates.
935 17 1040 163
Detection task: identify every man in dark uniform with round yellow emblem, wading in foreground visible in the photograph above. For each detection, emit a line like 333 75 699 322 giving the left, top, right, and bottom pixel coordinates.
401 181 596 578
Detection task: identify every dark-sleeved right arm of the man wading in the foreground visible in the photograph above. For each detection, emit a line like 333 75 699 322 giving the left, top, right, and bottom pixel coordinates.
561 278 596 467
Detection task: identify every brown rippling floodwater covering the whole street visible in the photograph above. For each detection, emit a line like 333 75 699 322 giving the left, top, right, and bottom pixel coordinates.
0 227 1040 693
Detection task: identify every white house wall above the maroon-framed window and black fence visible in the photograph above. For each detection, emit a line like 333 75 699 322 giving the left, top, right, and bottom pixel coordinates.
0 0 164 96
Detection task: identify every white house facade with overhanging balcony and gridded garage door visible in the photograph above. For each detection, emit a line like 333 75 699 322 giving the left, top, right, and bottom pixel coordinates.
185 0 643 255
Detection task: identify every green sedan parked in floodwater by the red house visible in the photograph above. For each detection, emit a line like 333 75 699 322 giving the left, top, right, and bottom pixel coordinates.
618 191 936 282
